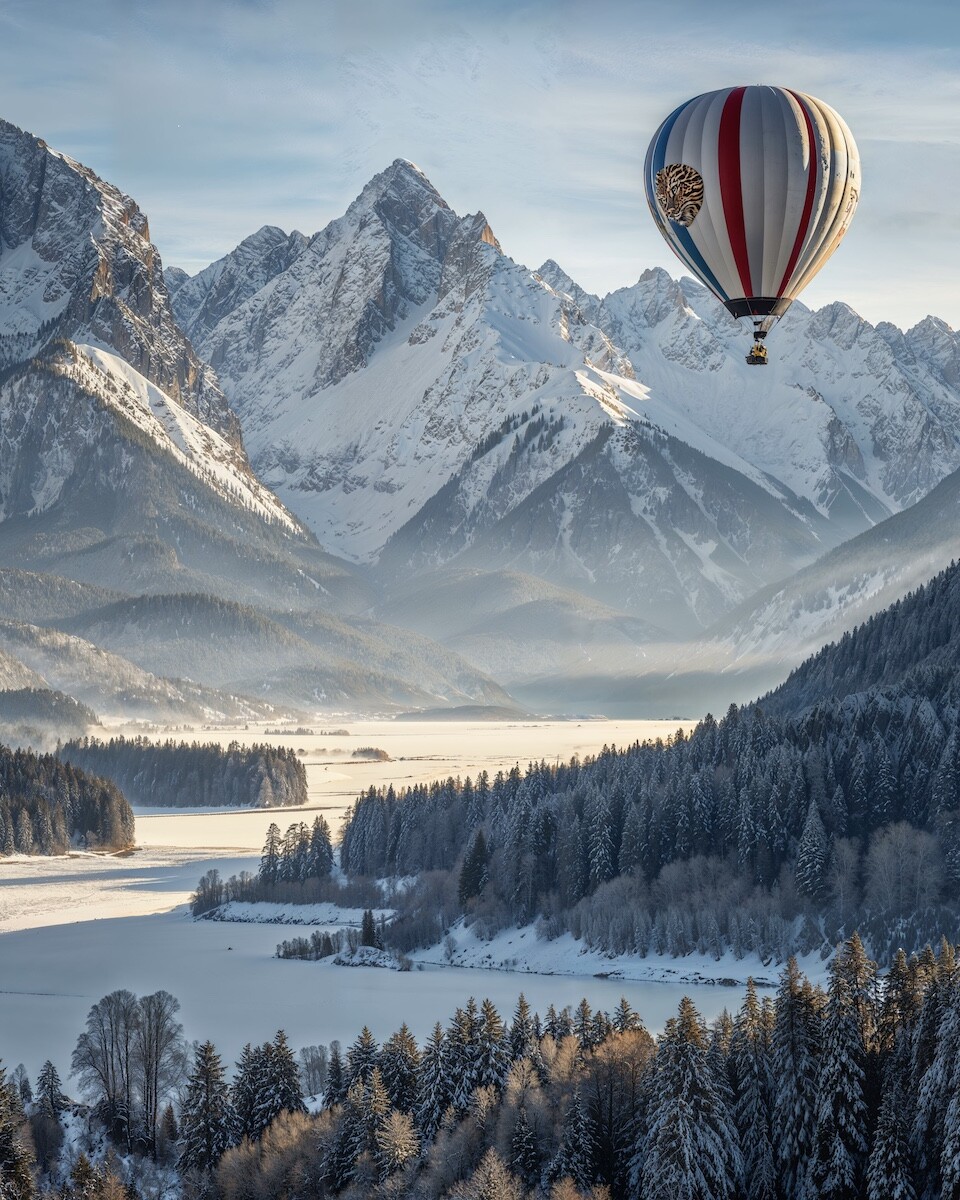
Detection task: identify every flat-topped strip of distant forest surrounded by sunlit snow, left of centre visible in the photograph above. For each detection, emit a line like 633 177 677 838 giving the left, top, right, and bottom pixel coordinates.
59 737 307 808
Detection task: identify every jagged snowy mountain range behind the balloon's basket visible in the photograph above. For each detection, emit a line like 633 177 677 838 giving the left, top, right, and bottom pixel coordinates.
552 263 960 532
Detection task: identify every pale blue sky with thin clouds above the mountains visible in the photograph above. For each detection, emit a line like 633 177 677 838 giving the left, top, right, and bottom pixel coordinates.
0 0 960 329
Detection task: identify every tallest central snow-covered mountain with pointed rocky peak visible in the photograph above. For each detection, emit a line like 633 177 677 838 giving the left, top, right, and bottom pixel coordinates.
173 160 864 632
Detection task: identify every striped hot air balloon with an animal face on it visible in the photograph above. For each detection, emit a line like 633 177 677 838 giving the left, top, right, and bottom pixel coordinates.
643 85 860 366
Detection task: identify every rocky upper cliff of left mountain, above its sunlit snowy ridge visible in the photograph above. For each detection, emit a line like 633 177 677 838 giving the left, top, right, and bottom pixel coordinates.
0 120 240 448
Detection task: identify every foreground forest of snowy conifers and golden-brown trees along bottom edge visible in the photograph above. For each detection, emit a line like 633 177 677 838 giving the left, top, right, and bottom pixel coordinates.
0 935 960 1200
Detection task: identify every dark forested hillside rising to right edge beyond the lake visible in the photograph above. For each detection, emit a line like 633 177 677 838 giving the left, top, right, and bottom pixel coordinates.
341 568 960 961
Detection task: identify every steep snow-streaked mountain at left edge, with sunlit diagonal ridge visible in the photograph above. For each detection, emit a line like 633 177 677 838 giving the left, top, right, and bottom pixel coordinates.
0 121 329 600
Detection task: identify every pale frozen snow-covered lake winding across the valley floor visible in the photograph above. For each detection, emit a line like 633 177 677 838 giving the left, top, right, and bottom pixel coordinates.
0 721 740 1078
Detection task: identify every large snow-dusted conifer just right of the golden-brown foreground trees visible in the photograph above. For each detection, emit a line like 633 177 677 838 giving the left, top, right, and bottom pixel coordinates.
636 997 743 1200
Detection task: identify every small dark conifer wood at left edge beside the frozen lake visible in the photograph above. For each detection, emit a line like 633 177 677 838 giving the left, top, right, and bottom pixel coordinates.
0 745 133 856
